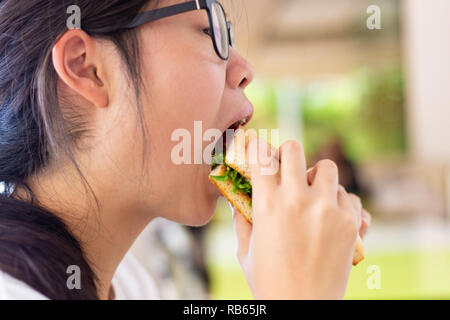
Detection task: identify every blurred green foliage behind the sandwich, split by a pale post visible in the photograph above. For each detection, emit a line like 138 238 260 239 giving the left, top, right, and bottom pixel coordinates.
247 66 407 162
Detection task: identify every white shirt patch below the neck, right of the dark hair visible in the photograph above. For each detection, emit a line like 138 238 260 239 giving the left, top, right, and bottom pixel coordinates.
112 252 160 300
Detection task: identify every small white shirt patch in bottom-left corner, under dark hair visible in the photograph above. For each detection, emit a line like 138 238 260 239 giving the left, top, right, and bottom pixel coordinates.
0 270 48 300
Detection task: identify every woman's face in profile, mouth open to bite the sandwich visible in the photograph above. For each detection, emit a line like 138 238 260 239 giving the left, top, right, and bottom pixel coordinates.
109 0 253 225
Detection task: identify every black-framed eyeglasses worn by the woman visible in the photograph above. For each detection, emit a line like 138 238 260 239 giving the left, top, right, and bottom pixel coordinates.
124 0 236 60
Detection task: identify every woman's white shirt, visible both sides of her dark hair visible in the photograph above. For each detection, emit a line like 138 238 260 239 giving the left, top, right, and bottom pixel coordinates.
0 252 160 300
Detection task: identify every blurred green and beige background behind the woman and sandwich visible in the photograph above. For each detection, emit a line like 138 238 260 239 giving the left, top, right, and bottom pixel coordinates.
132 0 450 299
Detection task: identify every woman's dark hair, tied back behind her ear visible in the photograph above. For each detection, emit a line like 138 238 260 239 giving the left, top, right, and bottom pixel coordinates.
0 0 153 299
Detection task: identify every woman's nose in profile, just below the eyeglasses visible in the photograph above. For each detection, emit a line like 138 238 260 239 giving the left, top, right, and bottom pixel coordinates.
227 47 255 90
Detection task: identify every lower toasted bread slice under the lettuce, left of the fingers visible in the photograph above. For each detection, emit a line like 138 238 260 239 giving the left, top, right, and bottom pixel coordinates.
209 164 253 223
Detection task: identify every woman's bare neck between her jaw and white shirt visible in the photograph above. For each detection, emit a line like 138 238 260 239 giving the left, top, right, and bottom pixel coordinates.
14 162 152 300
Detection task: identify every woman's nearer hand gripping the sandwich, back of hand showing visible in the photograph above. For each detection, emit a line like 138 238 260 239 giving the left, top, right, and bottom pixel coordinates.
234 138 370 299
